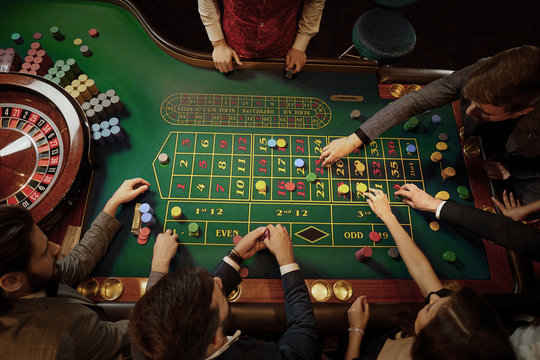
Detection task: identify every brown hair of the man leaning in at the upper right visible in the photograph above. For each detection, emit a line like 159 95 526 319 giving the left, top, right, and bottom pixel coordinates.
463 45 540 112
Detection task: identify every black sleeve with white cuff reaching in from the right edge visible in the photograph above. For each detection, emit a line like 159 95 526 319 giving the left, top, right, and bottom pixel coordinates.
440 201 540 261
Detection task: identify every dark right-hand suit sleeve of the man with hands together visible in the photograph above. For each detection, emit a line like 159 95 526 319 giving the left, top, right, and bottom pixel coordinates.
278 270 320 360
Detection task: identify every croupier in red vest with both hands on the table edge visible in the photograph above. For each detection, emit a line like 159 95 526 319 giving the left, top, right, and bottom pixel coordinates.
198 0 325 74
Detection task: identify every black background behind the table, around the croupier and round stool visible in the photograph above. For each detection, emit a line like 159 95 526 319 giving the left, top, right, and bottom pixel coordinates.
131 0 540 70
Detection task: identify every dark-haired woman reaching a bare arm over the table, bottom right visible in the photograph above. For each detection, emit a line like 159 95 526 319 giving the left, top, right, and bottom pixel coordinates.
346 189 516 360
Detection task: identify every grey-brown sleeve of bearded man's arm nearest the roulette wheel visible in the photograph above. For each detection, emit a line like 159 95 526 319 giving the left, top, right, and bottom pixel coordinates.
58 211 122 286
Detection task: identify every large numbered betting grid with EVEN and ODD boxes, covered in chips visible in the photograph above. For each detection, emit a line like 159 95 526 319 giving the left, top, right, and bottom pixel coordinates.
153 132 424 246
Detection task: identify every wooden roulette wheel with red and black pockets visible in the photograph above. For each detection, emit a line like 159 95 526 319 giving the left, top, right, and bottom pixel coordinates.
0 73 92 230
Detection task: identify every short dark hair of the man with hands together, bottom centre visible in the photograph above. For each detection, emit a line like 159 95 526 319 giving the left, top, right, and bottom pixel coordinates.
129 267 220 360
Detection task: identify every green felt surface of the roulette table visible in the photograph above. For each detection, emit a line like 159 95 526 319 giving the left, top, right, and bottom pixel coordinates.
0 1 502 286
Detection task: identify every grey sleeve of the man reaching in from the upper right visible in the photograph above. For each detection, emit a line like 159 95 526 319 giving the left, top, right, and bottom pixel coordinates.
357 62 479 141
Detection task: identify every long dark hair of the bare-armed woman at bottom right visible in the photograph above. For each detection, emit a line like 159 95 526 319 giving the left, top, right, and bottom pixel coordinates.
411 288 516 360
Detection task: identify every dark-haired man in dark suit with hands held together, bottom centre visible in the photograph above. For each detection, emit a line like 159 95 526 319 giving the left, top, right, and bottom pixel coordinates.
129 224 321 360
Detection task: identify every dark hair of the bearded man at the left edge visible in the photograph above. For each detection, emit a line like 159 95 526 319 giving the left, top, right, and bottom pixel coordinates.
0 205 34 309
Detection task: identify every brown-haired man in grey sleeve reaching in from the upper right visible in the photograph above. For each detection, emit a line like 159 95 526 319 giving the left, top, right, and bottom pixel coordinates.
320 45 540 204
